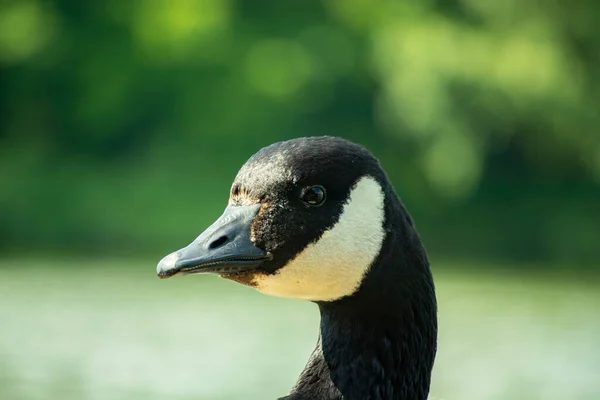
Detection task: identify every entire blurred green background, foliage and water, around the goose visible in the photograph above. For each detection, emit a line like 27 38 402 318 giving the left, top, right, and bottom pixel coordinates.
0 0 600 400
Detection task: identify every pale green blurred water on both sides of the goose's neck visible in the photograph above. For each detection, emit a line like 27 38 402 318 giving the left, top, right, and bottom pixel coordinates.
0 260 600 400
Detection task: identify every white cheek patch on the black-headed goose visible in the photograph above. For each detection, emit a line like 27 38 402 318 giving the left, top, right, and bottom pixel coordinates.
253 176 385 301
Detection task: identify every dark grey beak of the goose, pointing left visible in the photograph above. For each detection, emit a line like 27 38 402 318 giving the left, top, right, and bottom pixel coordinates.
156 204 272 279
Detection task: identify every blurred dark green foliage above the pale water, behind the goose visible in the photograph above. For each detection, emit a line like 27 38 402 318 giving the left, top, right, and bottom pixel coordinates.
0 0 600 261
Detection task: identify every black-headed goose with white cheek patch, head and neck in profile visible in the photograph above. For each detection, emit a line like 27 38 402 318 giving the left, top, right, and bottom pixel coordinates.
157 136 437 400
